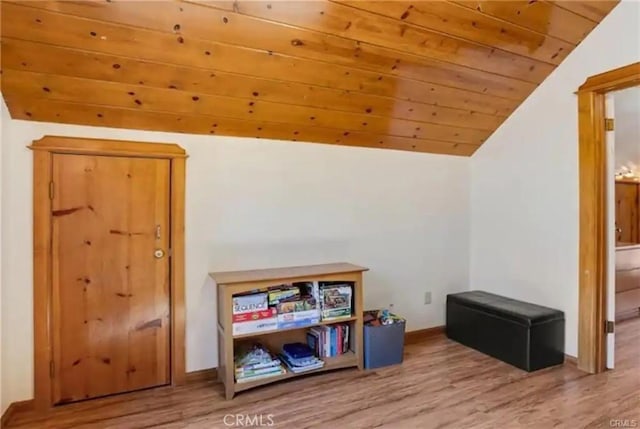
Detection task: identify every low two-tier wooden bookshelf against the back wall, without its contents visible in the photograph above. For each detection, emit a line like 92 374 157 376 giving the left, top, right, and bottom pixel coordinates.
209 263 368 399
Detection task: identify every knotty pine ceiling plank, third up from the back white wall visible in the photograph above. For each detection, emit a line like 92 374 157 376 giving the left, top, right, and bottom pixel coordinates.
2 38 510 123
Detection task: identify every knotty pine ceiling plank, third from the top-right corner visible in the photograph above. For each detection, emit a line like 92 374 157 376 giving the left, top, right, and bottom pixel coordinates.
335 0 575 65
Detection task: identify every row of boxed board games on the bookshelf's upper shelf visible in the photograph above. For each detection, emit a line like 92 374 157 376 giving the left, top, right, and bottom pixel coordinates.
232 282 353 335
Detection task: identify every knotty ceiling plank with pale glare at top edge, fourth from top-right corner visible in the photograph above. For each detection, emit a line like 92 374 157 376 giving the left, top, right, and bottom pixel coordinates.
200 1 554 83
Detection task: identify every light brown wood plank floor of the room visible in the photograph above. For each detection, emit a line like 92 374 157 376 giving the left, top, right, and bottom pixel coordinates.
6 319 640 429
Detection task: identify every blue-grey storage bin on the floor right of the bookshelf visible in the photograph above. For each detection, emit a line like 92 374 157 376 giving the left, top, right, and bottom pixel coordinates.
364 314 406 369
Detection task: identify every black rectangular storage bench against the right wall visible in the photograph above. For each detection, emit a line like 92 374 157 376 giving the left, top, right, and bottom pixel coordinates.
447 291 564 371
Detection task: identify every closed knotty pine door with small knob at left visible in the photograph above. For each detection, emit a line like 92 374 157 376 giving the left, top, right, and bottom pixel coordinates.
51 154 170 404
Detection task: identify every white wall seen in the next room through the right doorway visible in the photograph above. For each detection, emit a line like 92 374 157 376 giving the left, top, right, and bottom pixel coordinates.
613 87 640 175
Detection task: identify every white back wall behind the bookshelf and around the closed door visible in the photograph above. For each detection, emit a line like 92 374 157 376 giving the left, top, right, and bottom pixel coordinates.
2 111 470 408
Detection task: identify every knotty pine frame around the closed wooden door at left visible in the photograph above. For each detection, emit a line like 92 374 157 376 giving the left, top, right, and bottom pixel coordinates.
28 136 187 411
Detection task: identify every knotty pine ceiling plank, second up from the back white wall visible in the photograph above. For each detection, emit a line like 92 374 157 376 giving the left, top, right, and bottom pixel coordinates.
4 69 489 145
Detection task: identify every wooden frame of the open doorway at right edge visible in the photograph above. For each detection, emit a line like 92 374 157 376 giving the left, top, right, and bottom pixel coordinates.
577 62 640 373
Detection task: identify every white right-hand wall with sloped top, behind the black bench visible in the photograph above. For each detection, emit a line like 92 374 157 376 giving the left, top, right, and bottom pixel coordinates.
470 2 640 356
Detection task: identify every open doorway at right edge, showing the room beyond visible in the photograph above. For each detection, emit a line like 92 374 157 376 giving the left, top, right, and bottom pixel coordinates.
605 86 640 369
